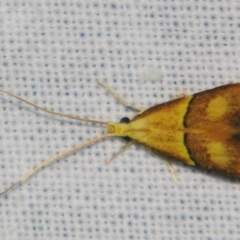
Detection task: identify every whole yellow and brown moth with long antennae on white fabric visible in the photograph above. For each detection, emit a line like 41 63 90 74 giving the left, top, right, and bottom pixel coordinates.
0 82 240 195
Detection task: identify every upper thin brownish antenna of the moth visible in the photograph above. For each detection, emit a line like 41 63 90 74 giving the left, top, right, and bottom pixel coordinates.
0 89 108 125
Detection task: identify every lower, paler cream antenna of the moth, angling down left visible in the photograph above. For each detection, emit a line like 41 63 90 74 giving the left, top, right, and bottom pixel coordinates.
0 133 114 196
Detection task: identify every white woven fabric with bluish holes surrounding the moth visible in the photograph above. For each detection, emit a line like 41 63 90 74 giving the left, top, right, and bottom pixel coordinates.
0 0 240 240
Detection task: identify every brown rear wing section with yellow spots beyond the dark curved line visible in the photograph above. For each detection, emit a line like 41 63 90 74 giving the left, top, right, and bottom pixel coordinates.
185 84 240 176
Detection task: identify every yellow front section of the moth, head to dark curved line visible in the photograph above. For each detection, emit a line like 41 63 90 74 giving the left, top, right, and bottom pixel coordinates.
110 96 194 165
